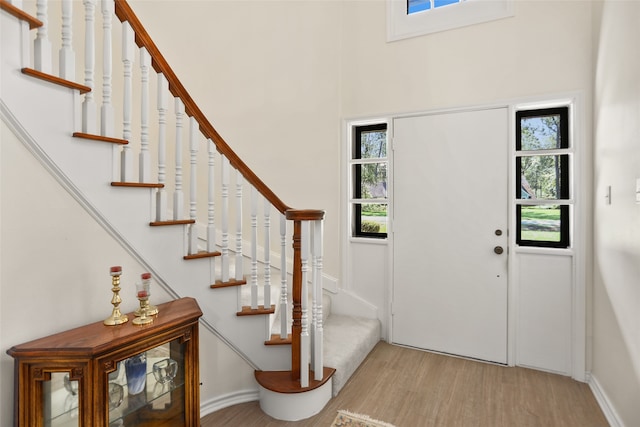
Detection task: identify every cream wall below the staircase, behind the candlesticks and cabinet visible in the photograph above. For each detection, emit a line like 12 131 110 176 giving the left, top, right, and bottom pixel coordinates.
0 122 256 426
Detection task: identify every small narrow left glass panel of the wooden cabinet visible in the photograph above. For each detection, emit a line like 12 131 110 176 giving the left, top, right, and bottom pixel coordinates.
42 372 80 427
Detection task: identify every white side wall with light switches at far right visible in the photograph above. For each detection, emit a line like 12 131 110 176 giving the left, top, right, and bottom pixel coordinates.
592 0 640 426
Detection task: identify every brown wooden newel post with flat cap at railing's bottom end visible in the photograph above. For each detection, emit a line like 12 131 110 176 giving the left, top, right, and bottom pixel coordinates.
286 209 324 380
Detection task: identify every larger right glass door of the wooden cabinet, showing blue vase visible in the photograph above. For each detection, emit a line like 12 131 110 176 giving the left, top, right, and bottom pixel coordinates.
107 339 185 427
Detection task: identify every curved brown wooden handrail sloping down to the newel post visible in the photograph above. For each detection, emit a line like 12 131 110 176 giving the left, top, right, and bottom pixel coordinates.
115 0 290 214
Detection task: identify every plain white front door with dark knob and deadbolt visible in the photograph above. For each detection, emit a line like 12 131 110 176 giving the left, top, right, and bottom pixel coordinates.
392 108 509 363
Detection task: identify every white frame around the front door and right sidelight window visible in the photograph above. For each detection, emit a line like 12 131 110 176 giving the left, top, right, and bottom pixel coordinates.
378 97 592 382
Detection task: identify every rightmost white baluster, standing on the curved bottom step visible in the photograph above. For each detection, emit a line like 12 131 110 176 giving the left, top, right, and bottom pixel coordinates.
312 221 324 381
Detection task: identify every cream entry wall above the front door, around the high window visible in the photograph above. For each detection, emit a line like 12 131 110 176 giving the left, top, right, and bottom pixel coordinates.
342 1 592 344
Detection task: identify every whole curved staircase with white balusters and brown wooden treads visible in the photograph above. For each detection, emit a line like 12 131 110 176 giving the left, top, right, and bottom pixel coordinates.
0 0 380 420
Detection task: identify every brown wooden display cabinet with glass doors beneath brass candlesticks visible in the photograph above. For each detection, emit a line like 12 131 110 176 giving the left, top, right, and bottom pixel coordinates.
7 298 202 427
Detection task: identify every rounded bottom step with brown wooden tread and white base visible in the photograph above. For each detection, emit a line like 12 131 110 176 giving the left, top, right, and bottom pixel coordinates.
255 367 335 421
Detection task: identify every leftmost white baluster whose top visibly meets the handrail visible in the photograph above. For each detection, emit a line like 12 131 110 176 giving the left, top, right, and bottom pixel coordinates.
120 21 134 182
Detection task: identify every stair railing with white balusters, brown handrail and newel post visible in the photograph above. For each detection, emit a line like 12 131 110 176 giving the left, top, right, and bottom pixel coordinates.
0 0 324 387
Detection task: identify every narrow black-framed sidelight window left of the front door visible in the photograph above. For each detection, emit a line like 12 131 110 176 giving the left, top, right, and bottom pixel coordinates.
350 123 388 238
